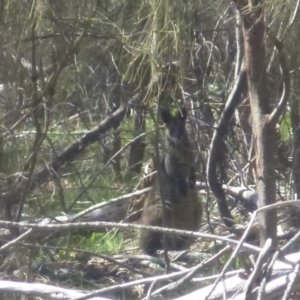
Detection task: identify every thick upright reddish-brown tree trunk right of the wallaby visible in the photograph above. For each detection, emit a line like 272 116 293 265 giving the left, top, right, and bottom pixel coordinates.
240 3 277 246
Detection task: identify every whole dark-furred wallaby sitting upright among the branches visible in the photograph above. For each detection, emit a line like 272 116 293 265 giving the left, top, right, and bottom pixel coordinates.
140 108 202 255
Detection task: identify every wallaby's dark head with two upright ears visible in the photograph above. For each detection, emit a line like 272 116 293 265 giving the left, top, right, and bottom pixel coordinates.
161 107 187 145
